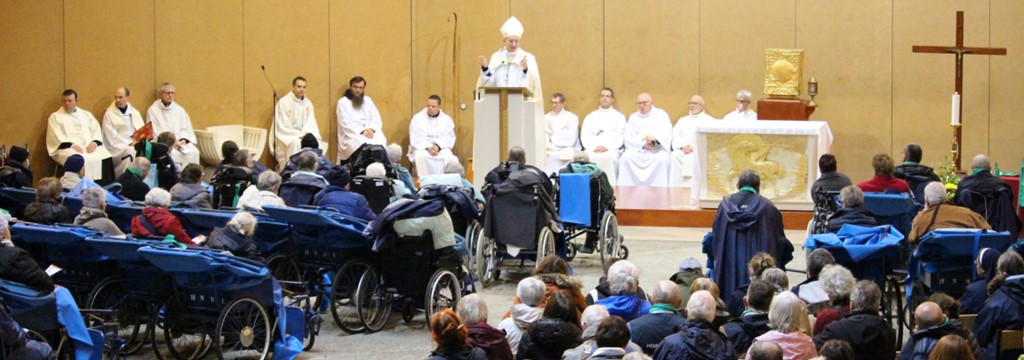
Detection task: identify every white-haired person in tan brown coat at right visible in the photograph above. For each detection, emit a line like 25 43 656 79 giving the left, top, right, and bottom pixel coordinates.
907 181 992 244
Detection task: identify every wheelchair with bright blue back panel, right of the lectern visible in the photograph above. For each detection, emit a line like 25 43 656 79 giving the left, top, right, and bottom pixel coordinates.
554 174 630 264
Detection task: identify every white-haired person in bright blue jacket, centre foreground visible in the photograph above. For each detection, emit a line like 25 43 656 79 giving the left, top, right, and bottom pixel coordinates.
595 260 651 321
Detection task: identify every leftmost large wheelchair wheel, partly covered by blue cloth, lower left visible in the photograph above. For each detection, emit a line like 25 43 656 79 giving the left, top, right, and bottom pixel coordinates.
86 279 151 355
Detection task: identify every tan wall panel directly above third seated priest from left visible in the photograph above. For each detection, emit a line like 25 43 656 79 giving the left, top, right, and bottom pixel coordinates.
154 0 244 129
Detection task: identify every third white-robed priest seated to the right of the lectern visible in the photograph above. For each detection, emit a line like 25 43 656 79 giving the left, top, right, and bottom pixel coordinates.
618 93 672 186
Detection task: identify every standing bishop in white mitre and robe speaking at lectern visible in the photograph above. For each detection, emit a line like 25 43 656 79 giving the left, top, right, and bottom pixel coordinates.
476 16 544 100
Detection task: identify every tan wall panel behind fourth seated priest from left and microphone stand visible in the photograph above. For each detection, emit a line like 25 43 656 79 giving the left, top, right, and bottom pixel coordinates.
242 0 327 165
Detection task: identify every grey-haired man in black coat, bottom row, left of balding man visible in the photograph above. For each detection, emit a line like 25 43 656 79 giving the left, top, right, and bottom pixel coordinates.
814 280 896 360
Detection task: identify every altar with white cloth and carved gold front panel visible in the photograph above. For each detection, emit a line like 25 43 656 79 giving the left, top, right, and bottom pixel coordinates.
690 120 833 211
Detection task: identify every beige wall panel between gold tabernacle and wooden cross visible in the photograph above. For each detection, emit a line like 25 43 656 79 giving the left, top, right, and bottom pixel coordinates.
794 0 893 182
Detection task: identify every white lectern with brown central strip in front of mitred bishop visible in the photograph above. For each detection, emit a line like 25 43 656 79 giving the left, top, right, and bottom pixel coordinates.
473 87 546 186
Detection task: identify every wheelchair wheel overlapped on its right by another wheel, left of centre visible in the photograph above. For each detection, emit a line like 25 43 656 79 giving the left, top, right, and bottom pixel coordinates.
331 260 370 333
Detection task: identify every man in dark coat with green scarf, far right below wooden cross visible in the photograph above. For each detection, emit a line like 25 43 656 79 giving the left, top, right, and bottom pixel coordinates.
953 154 1021 236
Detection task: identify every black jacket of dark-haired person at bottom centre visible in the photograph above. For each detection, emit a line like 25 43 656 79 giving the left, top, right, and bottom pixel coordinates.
515 319 583 360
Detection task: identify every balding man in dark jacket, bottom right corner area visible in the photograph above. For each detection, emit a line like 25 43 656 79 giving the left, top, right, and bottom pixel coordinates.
899 302 982 360
